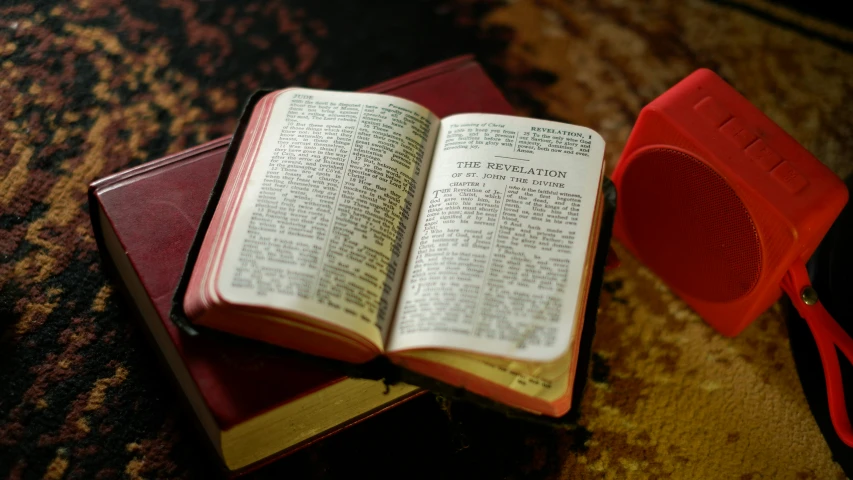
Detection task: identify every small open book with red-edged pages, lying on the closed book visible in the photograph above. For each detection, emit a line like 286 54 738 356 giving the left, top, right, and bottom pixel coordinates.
178 89 604 416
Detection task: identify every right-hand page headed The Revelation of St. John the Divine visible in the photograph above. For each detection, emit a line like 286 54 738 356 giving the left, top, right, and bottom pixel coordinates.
388 114 604 362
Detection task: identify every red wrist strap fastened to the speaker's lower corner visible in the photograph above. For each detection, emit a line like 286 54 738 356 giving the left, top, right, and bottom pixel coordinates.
782 263 853 447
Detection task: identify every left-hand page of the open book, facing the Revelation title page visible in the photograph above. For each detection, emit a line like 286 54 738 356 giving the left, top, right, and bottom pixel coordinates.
217 89 439 348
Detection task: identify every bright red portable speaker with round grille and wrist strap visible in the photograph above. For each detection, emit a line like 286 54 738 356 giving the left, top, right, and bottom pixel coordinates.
613 69 853 445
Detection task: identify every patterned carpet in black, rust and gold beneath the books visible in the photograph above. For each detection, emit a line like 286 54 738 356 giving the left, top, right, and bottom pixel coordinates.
0 0 853 480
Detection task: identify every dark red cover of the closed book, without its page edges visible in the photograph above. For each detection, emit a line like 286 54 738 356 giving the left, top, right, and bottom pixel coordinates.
89 57 512 472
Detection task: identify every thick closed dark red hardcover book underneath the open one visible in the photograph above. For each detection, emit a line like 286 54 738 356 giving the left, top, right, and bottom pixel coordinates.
89 57 512 472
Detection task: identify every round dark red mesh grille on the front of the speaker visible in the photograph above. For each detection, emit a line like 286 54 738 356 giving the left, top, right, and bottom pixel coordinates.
619 148 762 302
